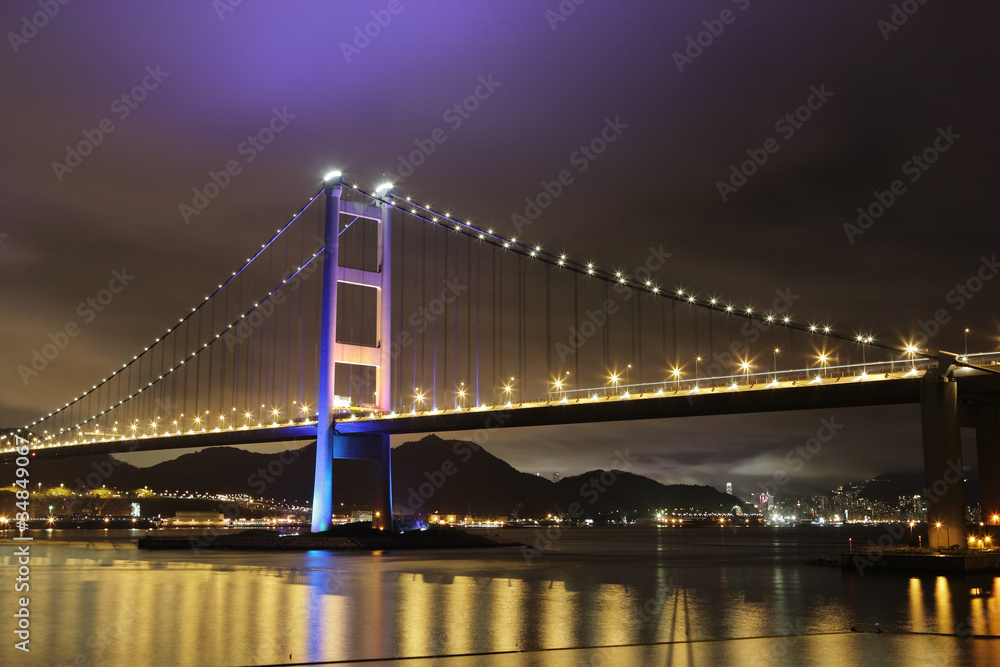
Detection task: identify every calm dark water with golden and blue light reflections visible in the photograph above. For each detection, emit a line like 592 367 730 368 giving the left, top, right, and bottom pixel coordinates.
0 528 1000 666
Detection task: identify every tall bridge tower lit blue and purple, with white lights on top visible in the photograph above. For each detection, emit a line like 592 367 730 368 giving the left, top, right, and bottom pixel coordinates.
312 172 392 532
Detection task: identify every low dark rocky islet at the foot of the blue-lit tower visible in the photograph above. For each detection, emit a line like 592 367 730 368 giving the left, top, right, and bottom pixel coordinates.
138 522 523 551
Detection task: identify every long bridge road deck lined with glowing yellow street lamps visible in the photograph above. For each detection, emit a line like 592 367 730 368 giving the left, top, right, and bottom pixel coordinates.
7 371 1000 461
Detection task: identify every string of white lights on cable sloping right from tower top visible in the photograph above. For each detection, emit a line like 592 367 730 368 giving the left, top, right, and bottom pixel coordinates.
332 176 904 354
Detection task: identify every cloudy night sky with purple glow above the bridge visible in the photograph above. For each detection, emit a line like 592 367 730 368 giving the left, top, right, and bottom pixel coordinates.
0 0 1000 495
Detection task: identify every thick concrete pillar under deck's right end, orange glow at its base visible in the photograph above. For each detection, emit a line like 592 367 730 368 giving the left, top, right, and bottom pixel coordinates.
920 373 966 549
